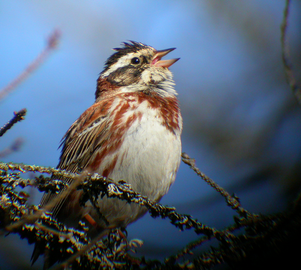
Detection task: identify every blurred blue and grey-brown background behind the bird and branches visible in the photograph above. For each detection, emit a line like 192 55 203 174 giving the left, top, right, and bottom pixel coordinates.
0 0 301 269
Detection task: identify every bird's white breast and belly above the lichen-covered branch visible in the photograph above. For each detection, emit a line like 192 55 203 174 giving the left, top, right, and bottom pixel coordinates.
109 108 181 200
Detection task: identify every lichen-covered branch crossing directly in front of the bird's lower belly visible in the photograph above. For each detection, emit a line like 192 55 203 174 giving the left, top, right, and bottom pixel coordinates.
0 162 220 237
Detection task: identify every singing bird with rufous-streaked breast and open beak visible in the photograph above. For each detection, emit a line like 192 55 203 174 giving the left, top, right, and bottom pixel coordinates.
32 41 183 266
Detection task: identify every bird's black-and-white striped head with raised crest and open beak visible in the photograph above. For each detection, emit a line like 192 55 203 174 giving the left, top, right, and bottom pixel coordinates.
96 41 179 98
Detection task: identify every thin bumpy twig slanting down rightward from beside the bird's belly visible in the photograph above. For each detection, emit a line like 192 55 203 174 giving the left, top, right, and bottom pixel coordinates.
182 152 252 217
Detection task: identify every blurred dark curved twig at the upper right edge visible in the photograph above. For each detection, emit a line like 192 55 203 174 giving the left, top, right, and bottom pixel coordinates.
281 0 301 104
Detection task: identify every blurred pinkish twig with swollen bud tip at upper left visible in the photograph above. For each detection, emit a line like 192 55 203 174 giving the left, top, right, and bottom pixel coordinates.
0 30 60 100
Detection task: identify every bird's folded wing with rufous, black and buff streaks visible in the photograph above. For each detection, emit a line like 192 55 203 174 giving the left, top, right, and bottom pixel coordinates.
41 99 113 217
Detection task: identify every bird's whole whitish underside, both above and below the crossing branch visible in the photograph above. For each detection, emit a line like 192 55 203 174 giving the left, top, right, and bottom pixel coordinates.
91 103 181 227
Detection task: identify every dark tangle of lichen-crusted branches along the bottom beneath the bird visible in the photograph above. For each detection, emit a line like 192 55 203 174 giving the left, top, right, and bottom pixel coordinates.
0 161 301 269
